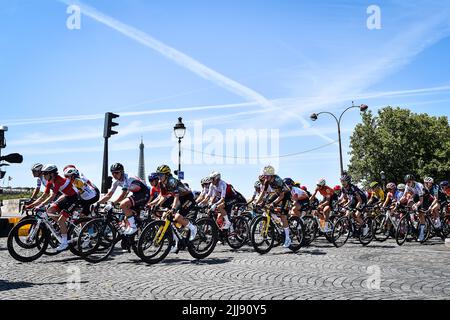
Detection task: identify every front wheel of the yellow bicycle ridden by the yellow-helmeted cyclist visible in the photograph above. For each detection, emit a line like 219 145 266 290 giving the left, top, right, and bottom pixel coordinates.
137 220 173 264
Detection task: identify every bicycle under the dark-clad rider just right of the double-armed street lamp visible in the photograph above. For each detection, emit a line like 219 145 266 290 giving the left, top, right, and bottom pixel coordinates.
332 209 375 248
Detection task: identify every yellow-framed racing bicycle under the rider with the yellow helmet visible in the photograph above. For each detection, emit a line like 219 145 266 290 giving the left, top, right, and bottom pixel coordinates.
137 208 218 264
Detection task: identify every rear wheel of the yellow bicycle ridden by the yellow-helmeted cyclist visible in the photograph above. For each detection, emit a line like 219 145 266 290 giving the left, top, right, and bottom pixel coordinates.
187 218 218 259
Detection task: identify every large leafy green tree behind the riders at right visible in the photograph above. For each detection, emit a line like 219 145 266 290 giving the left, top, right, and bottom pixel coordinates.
349 107 450 183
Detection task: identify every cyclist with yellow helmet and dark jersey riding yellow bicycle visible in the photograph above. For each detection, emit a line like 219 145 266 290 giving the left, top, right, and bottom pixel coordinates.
156 164 197 240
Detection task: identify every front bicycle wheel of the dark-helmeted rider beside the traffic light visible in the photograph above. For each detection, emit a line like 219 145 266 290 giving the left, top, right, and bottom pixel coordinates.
76 218 117 263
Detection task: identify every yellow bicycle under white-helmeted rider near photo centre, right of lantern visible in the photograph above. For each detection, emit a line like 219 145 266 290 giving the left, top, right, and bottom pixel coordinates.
250 206 304 254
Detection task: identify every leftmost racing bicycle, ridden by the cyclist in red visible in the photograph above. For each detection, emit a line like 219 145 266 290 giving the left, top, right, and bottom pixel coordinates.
7 209 91 262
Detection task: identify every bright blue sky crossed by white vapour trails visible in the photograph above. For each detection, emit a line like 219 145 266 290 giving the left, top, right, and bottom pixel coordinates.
0 0 450 196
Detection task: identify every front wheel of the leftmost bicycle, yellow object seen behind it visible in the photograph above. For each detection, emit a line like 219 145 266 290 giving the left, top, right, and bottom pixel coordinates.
7 219 49 262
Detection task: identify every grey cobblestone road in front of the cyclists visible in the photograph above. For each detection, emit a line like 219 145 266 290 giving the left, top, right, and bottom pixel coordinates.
0 239 450 300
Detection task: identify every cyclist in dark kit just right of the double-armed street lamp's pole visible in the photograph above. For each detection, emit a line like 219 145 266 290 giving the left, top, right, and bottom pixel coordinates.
339 173 369 236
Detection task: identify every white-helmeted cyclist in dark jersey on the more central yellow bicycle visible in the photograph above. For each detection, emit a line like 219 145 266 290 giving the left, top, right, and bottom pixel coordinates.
256 166 292 248
